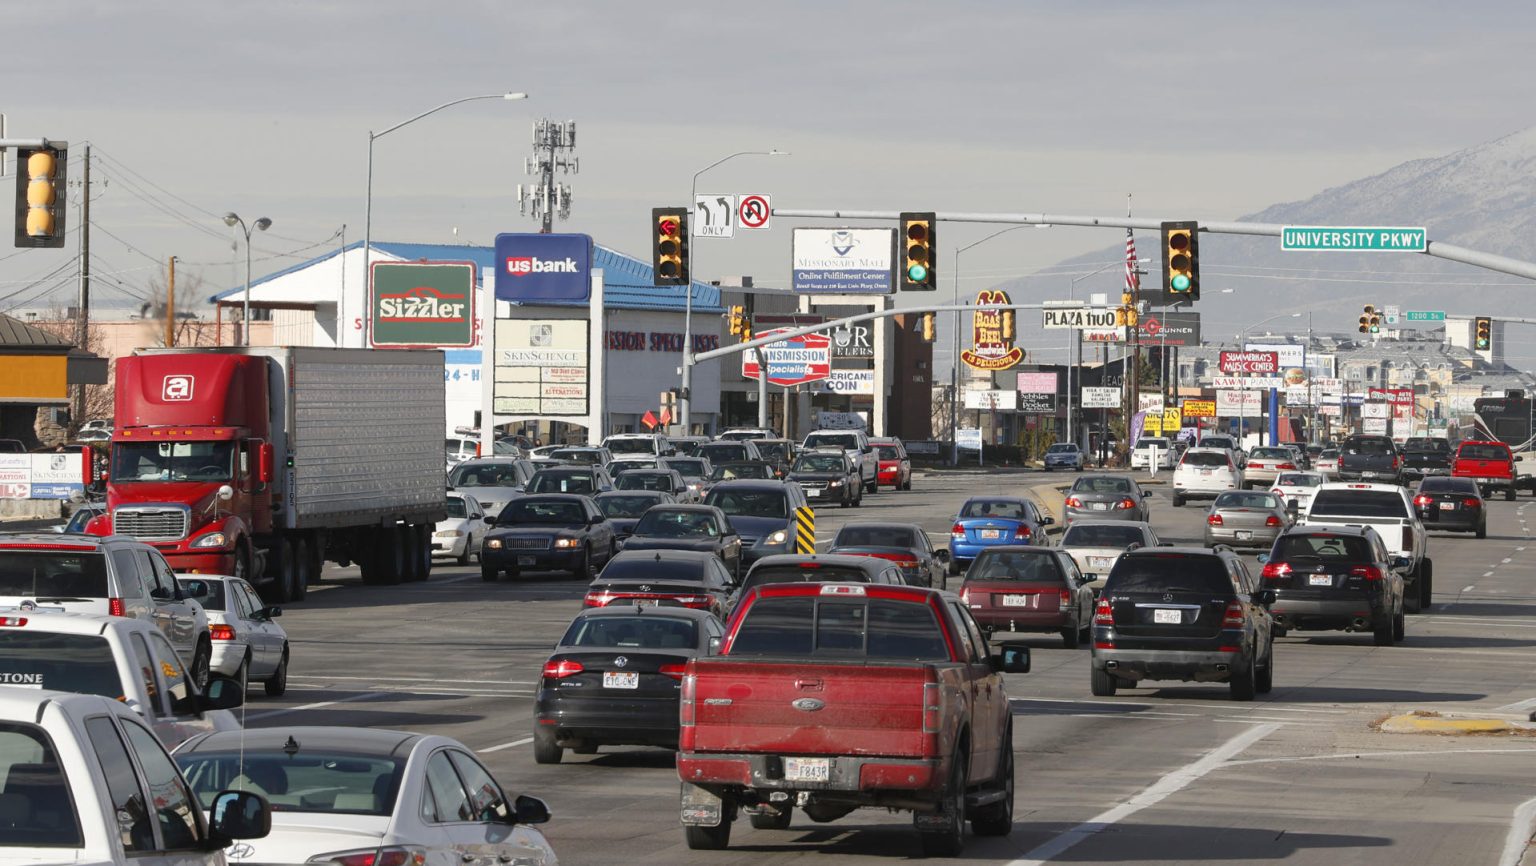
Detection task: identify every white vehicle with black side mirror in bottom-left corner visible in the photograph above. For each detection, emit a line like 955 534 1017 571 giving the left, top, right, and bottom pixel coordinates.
0 688 270 866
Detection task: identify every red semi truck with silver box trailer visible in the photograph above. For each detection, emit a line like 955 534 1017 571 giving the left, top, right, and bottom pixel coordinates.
88 347 447 603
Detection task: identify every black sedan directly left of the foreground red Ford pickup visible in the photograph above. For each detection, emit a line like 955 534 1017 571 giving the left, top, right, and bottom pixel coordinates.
533 605 725 763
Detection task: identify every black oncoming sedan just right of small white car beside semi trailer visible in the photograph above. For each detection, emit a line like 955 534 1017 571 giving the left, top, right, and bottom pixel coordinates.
481 493 619 580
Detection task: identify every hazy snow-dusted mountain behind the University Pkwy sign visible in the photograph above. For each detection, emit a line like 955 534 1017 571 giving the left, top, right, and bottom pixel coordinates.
1001 127 1536 347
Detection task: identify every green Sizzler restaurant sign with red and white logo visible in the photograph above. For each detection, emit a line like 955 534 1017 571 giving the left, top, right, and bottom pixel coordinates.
369 261 475 349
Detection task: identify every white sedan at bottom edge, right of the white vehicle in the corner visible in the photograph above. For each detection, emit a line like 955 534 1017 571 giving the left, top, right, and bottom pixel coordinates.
174 726 554 866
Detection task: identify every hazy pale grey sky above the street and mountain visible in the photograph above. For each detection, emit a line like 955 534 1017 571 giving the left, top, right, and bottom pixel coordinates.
0 0 1536 348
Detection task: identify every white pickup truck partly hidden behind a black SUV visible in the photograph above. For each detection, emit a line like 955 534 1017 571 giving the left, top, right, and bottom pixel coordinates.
1296 482 1435 613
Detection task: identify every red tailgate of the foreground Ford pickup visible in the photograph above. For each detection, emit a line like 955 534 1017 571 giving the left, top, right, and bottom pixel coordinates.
682 657 938 757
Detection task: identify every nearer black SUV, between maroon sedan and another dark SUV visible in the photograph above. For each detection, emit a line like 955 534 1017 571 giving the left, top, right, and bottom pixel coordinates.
1092 545 1275 700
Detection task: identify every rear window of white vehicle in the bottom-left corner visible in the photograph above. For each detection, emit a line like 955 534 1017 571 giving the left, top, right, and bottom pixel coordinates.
0 722 81 847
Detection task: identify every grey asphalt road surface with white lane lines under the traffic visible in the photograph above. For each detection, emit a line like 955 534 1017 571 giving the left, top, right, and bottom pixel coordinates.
236 471 1536 866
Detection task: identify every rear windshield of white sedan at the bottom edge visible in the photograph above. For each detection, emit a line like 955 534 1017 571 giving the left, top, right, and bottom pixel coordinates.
172 746 406 815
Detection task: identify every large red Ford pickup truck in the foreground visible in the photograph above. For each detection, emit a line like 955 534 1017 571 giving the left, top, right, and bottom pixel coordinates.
677 583 1029 857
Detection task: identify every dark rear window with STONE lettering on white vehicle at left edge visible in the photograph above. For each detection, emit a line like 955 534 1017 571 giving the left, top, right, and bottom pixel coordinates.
0 632 127 700
